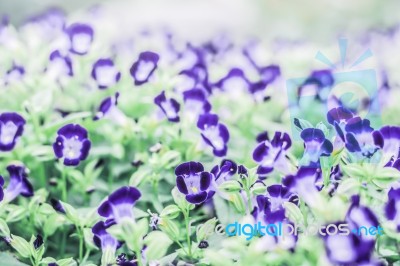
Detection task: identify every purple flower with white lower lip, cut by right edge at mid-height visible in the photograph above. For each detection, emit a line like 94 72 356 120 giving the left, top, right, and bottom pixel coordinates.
372 126 400 161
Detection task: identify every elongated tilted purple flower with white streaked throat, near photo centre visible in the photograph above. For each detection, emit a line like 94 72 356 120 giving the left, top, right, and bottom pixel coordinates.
197 114 229 157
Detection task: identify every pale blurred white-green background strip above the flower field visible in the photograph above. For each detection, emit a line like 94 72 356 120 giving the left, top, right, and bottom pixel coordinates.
0 0 400 42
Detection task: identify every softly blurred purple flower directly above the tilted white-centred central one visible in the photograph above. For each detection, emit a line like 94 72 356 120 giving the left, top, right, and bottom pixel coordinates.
183 89 211 118
